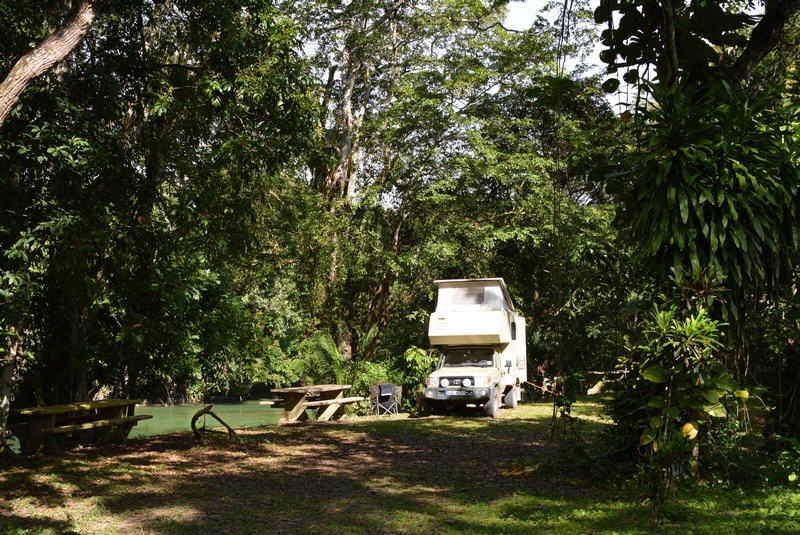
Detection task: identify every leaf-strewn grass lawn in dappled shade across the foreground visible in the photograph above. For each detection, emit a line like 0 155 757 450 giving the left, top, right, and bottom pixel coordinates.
0 401 800 534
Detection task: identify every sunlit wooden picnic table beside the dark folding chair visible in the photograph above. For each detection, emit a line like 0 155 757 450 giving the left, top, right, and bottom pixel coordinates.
272 385 364 424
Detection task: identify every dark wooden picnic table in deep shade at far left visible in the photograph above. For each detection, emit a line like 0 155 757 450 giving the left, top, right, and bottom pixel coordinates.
11 399 152 453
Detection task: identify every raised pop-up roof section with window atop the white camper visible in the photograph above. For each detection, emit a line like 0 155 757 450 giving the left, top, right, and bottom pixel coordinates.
433 278 514 312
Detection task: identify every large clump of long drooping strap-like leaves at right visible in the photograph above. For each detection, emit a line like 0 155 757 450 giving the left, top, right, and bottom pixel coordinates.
619 82 800 296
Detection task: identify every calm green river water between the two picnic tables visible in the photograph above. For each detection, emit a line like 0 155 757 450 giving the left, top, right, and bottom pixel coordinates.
128 401 283 438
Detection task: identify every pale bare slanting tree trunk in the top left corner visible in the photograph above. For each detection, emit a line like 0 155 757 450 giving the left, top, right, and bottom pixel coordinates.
0 0 97 128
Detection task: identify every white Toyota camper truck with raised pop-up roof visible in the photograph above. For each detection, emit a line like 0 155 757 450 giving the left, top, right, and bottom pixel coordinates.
424 279 528 418
